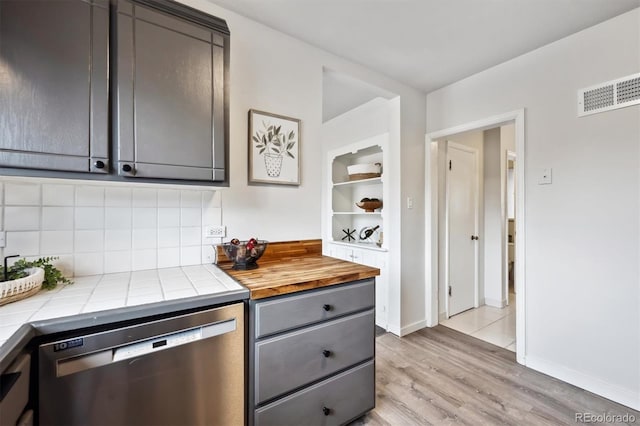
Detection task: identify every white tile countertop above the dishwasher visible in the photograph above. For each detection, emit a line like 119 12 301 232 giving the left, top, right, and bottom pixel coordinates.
0 265 248 349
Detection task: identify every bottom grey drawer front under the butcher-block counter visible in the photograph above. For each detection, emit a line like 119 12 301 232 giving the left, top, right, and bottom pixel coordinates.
255 361 376 426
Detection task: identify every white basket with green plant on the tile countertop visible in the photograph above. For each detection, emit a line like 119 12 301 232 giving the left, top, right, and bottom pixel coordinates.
0 255 72 306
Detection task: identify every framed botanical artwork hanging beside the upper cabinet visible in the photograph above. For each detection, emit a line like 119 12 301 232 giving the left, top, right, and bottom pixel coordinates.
249 109 301 185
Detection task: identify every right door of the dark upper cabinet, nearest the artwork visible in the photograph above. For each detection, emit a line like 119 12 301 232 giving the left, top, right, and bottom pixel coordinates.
114 0 228 181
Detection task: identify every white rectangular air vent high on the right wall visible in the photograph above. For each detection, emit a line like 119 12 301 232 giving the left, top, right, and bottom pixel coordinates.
578 73 640 117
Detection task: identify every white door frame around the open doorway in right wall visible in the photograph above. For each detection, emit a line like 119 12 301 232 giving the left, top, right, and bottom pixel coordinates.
424 108 526 365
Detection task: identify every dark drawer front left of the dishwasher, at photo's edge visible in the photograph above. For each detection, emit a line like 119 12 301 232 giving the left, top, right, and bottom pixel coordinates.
0 354 31 425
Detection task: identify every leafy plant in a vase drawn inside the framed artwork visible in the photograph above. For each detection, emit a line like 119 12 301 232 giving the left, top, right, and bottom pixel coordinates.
252 121 296 177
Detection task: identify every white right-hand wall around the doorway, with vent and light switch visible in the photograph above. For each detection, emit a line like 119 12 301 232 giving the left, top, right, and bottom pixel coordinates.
427 9 640 409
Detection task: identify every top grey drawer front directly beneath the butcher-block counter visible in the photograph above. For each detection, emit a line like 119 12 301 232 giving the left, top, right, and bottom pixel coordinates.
255 279 376 338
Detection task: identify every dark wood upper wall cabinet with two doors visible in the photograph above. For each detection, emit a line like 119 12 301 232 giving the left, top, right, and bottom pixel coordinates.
0 0 229 184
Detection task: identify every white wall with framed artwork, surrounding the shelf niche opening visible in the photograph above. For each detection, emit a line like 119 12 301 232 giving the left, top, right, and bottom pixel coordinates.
180 0 426 333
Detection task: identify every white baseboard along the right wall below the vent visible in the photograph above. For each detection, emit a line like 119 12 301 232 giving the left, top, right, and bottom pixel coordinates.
526 354 640 410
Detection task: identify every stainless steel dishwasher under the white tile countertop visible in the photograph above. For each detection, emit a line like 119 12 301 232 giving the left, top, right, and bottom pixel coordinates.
38 303 245 426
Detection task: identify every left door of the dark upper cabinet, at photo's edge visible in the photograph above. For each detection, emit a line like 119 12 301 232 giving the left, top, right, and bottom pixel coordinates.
0 0 109 173
